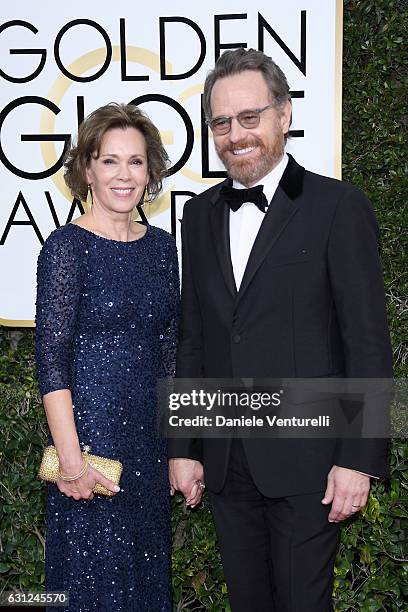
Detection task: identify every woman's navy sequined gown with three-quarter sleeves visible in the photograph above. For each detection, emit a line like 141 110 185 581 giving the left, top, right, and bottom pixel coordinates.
36 224 179 612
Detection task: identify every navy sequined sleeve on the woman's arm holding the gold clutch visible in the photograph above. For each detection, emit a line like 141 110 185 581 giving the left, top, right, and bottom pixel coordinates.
35 228 81 395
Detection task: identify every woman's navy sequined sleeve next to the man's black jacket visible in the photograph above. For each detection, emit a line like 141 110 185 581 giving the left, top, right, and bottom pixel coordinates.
160 235 180 376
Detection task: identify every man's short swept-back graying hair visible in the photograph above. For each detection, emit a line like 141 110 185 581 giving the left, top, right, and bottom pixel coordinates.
203 49 290 121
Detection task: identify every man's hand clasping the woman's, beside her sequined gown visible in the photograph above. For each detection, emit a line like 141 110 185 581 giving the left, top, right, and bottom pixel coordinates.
169 459 204 508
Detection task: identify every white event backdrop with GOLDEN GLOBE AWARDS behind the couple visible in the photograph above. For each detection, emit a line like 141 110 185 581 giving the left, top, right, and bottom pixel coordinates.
0 0 342 326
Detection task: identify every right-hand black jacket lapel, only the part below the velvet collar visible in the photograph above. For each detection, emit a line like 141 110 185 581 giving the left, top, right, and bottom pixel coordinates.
238 185 298 301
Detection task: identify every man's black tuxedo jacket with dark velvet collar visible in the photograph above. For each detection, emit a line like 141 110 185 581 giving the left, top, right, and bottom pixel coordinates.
169 156 392 497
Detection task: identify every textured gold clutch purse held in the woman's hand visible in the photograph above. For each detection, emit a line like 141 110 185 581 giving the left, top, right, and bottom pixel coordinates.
38 446 123 497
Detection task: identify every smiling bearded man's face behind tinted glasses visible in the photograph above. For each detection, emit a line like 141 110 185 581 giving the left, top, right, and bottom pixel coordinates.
211 70 291 187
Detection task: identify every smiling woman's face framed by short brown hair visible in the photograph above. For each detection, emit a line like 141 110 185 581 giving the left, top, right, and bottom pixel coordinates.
86 127 149 213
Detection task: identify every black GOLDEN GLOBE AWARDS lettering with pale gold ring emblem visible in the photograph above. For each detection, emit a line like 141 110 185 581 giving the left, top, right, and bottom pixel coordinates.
0 10 306 245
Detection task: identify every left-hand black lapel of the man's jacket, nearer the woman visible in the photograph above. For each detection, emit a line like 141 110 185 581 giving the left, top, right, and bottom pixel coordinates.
210 191 237 299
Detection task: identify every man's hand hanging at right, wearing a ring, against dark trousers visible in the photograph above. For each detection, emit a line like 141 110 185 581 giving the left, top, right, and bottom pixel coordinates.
322 465 370 523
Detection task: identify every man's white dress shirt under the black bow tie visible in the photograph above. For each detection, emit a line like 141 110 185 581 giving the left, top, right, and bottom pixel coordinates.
230 153 289 290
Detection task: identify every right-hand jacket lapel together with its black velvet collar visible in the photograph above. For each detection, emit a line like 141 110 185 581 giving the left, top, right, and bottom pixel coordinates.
237 155 304 302
